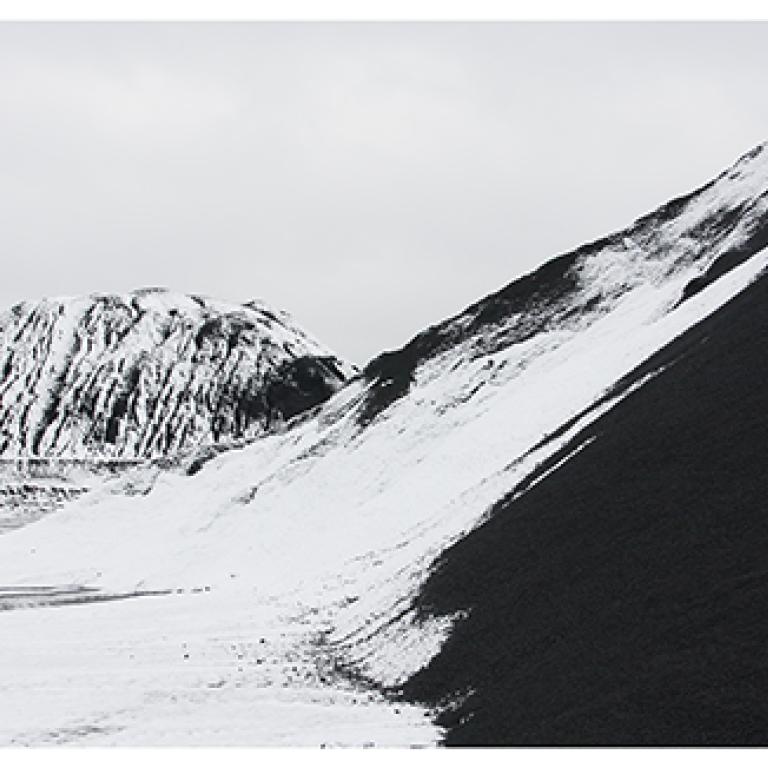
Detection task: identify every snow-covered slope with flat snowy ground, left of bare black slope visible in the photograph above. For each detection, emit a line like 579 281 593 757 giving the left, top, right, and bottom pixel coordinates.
0 140 768 744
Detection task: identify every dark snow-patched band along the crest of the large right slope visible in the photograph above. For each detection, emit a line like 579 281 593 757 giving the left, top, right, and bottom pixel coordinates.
361 142 768 423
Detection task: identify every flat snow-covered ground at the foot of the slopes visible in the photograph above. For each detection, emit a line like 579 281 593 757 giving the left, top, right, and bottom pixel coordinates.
0 589 438 746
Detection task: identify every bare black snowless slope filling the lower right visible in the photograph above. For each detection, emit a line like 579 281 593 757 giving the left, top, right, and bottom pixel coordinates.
405 262 768 745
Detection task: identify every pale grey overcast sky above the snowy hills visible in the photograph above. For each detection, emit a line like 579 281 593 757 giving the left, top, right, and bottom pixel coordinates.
0 23 768 363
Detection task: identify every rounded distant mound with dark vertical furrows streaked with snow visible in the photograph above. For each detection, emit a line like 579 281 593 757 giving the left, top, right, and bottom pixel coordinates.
0 289 351 458
